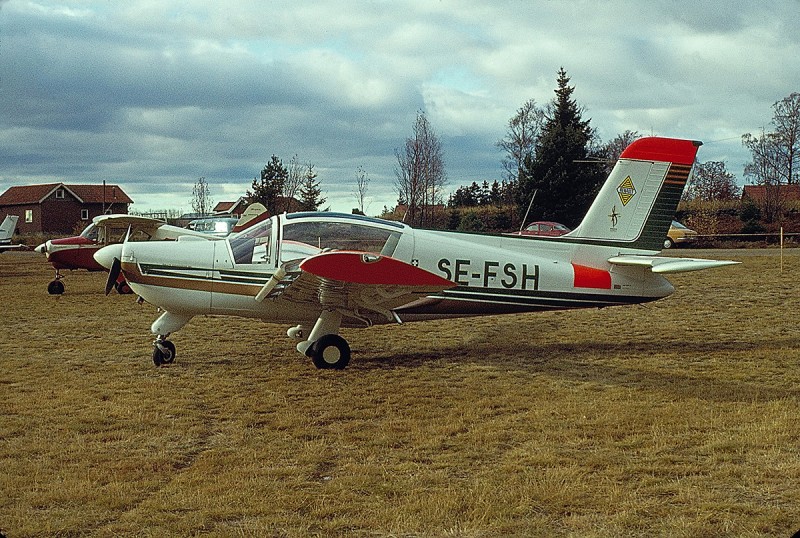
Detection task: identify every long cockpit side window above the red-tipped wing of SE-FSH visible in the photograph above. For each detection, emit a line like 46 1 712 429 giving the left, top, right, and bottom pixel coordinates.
281 221 400 262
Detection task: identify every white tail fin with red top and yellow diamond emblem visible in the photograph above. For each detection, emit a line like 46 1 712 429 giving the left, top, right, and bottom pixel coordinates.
564 137 702 252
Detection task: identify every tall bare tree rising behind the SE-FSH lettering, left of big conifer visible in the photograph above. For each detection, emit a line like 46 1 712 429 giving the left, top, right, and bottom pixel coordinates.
395 112 446 226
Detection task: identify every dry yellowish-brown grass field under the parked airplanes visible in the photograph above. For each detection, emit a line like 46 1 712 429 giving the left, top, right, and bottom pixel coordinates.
0 251 800 538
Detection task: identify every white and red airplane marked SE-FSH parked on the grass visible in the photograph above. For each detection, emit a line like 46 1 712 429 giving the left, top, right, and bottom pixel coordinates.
95 138 736 369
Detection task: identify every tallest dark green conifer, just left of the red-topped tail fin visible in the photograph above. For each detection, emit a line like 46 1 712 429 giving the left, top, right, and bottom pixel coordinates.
517 67 603 227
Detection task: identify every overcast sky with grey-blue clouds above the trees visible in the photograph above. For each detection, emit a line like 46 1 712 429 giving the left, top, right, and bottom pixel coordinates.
0 0 800 215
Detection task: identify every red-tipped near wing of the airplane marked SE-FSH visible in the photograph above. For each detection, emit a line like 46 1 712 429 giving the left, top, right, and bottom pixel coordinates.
267 251 456 325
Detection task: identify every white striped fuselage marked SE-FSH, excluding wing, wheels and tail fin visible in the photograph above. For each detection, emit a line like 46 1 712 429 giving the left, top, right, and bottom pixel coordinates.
114 214 673 325
